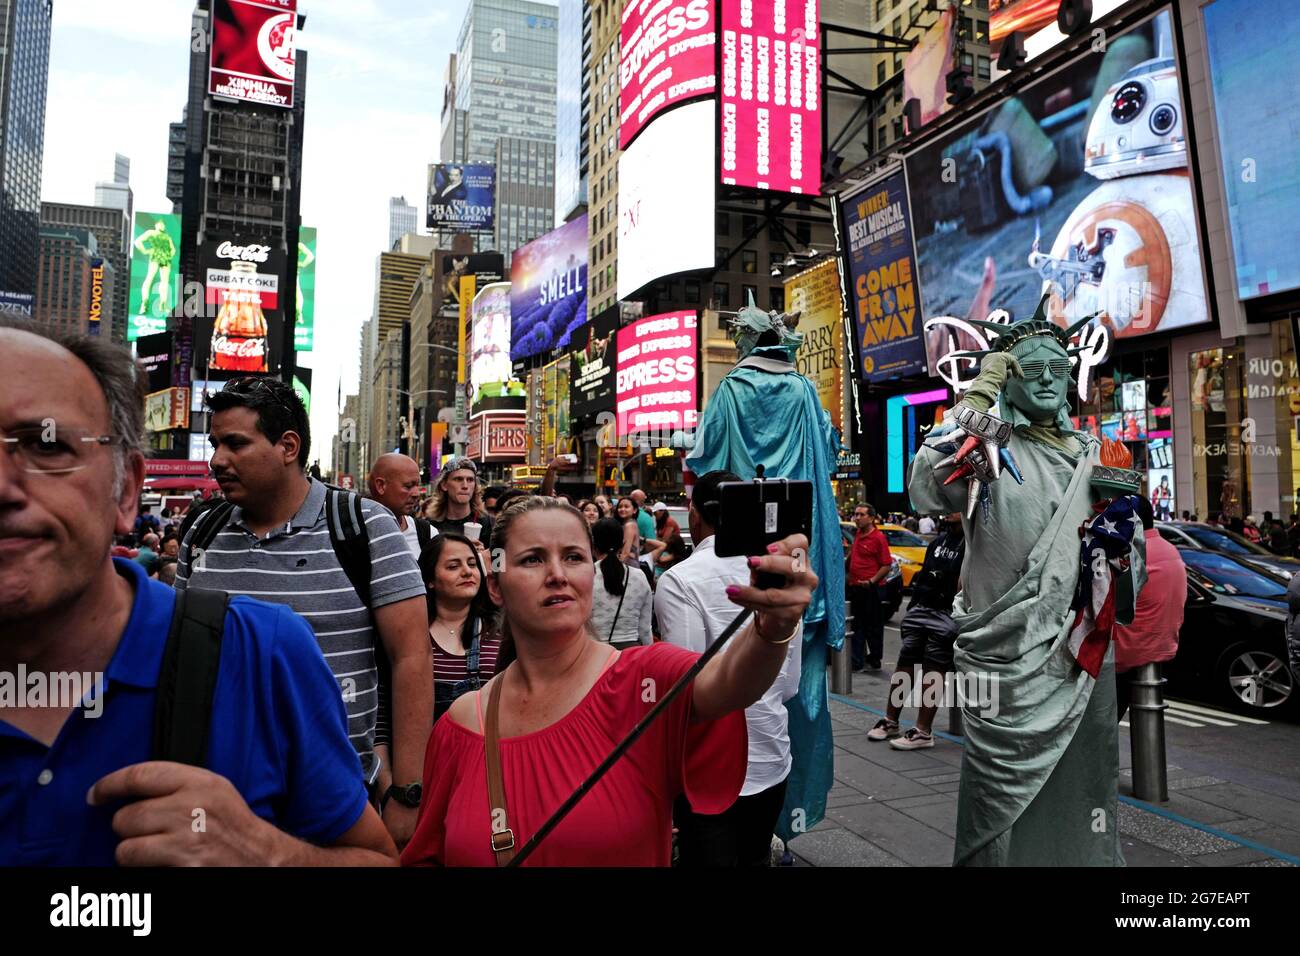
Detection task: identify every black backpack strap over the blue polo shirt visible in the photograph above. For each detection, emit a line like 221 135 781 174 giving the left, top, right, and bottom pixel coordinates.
153 588 230 766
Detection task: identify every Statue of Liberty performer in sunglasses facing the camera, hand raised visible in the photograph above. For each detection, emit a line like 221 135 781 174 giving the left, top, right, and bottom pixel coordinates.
907 297 1145 866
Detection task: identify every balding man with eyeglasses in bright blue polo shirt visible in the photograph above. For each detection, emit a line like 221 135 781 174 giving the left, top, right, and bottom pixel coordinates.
0 324 397 866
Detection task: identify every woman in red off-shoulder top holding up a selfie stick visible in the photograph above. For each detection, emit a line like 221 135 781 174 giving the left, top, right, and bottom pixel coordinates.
402 497 816 866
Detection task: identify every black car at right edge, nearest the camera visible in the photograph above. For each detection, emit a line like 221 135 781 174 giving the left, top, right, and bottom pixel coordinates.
1164 548 1300 715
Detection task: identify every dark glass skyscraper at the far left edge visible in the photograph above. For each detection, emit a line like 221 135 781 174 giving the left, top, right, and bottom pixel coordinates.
0 0 53 312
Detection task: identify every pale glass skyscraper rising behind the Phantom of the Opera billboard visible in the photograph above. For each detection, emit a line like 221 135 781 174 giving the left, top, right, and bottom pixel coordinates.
442 0 559 258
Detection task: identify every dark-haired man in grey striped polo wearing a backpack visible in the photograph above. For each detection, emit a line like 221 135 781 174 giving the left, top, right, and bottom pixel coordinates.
176 378 433 847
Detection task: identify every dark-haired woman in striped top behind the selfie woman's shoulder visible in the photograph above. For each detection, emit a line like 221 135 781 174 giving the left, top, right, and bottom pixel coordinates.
420 532 501 721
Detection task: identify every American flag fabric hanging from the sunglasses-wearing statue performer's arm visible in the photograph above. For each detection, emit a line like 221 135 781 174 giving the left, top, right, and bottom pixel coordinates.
1070 494 1141 679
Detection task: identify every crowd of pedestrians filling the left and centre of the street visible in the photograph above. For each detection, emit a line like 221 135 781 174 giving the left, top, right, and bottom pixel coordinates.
0 321 818 866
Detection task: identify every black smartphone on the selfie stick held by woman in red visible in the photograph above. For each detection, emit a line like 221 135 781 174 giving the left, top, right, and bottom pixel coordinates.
714 479 813 588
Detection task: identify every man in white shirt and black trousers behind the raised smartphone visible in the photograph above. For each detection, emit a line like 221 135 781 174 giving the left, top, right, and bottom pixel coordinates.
654 471 803 866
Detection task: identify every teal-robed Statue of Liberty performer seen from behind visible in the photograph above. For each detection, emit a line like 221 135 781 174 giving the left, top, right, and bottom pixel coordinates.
686 295 844 840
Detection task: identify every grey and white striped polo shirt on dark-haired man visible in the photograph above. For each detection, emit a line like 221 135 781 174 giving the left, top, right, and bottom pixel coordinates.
176 479 425 780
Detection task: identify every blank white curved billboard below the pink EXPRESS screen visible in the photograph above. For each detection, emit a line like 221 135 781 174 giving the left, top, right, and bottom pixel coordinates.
618 101 718 299
